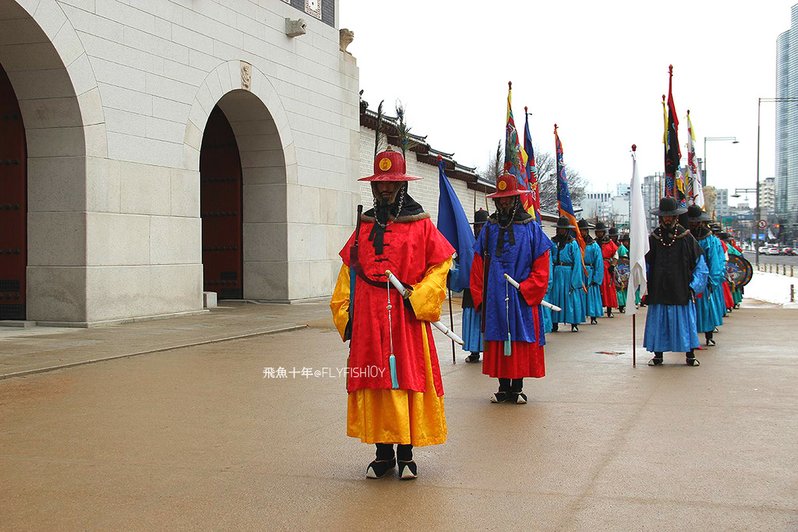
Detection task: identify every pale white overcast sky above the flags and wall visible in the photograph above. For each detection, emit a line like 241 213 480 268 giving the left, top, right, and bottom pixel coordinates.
340 0 798 204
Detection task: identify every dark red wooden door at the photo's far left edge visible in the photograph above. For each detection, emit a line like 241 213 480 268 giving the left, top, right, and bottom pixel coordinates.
0 66 28 320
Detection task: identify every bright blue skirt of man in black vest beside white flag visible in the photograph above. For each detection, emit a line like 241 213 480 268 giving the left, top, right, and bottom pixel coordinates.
643 303 698 353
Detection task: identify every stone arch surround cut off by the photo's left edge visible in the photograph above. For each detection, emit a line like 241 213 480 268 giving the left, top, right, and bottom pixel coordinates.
0 0 107 322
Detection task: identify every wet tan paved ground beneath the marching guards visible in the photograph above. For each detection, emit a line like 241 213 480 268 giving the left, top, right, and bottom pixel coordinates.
0 303 798 531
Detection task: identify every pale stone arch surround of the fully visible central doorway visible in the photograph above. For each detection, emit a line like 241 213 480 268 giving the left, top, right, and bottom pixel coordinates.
184 61 296 302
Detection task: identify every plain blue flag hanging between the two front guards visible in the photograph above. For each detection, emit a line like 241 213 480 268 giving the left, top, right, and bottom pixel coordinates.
438 157 475 292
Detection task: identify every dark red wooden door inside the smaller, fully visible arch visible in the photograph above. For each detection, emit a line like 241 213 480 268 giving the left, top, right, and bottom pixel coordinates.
200 106 244 299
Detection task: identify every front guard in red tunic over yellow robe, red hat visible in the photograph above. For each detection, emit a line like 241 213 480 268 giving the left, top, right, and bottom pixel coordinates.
330 150 454 479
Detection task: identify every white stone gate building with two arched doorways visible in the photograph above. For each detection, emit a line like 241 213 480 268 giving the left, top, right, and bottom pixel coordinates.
0 0 359 326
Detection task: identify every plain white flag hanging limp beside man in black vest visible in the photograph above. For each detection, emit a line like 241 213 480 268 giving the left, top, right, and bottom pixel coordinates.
626 144 648 314
